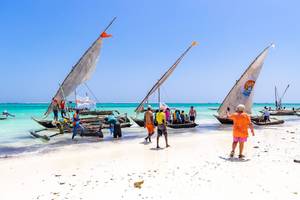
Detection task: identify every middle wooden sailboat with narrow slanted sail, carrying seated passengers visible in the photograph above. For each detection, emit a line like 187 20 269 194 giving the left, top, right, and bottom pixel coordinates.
132 42 197 128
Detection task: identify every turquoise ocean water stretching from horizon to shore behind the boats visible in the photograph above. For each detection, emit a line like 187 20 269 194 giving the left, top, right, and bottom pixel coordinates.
0 103 300 155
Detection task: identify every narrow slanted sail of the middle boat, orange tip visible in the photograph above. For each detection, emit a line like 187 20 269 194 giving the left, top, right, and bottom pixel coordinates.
135 42 197 113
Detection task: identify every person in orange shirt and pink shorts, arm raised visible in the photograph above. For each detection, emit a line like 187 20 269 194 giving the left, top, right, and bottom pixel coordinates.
228 104 254 158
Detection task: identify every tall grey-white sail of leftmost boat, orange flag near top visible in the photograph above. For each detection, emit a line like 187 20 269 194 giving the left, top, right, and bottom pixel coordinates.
44 18 116 116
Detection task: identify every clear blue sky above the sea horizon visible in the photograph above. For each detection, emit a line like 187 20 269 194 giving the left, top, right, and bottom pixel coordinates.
0 0 300 102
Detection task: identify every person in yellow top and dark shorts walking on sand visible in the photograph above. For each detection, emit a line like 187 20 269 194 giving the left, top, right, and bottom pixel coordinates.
156 108 170 148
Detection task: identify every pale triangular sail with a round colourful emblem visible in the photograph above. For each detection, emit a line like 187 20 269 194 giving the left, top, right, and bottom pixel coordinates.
218 44 274 117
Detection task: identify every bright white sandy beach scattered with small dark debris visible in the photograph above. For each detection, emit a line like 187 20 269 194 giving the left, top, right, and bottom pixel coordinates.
0 123 300 200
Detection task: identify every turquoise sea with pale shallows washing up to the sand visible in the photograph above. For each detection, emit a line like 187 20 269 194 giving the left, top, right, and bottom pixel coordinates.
0 103 300 156
